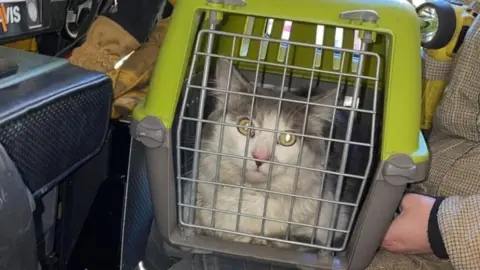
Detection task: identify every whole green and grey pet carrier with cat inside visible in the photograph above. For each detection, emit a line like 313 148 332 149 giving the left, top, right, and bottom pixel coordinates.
132 0 428 269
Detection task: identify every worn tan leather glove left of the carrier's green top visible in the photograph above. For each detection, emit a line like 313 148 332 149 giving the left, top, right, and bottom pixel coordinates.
69 5 175 118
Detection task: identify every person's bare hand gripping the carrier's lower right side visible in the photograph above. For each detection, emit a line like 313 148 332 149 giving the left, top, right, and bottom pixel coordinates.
382 194 435 254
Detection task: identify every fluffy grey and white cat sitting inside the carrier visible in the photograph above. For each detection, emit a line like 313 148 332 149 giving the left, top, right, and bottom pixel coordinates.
190 60 357 251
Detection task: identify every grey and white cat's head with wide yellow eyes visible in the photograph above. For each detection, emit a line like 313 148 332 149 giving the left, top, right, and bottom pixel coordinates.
202 60 335 186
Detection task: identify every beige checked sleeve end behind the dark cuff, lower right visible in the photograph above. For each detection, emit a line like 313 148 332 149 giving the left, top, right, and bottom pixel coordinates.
437 195 480 270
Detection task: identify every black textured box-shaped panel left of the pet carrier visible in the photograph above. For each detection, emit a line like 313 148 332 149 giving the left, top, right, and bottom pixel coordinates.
0 48 112 196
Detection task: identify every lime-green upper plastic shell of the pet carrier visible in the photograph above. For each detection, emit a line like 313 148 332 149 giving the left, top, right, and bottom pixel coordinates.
133 0 428 163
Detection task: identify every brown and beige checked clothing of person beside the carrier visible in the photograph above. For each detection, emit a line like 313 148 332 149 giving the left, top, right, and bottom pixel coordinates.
368 1 480 270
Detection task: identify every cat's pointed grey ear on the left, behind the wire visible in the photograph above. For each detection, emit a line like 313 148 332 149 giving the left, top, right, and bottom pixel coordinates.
215 59 252 93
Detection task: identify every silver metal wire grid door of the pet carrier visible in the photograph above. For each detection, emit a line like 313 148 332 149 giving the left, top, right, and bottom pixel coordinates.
176 26 381 251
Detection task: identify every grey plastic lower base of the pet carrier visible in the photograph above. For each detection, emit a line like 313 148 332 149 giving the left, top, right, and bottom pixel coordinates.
132 75 428 270
